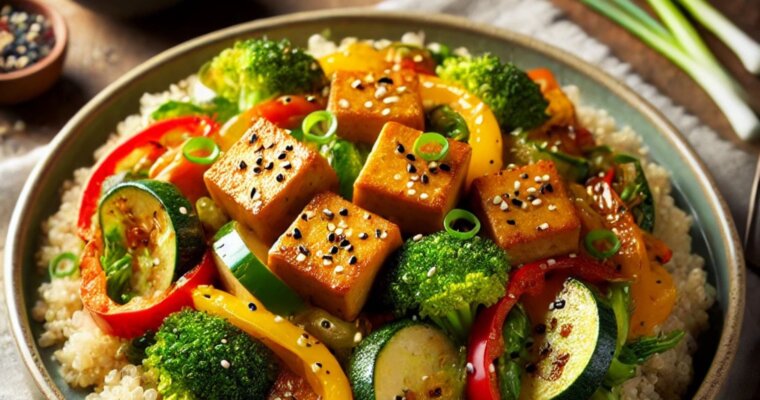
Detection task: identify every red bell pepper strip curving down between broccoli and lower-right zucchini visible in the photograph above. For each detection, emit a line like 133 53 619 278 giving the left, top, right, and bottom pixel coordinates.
467 256 622 400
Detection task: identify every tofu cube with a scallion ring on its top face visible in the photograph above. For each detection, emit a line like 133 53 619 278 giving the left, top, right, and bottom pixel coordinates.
354 122 472 234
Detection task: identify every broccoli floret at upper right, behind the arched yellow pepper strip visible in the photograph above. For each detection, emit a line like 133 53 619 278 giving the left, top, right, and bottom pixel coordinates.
436 54 549 130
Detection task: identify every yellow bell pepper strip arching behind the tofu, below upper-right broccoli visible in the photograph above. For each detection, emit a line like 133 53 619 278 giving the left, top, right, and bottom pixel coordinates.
419 75 503 187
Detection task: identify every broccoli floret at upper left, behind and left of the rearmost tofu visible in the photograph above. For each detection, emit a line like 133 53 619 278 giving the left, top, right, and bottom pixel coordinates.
199 39 327 110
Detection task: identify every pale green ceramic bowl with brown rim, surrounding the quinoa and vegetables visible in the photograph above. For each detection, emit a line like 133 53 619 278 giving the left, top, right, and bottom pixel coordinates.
5 9 744 399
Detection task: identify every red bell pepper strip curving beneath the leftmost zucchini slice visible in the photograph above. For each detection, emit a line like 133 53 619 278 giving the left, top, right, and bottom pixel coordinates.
79 238 216 339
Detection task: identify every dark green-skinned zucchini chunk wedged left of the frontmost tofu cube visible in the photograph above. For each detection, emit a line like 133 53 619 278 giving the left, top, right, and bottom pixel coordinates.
212 221 306 316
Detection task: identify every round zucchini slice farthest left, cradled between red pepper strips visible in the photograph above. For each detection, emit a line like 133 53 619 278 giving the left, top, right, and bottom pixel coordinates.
98 179 206 303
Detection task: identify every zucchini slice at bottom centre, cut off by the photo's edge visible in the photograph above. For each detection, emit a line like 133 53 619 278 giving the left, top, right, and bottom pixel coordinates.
348 320 465 400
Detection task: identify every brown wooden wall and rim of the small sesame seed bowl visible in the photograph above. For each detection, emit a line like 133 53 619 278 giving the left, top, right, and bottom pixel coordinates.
0 0 69 105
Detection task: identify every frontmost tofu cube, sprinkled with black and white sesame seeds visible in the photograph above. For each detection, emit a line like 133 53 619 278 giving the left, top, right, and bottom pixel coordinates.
268 192 402 321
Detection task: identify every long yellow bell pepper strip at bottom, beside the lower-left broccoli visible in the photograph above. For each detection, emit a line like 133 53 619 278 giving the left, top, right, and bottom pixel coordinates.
193 286 353 400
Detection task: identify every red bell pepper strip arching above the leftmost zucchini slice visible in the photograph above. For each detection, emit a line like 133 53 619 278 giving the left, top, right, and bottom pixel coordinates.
77 116 219 240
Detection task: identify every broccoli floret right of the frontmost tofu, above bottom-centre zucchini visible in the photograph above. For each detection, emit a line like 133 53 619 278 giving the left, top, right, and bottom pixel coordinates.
387 232 509 339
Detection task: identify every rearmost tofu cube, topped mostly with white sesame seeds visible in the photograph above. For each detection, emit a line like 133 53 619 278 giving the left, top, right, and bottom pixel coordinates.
327 71 425 144
